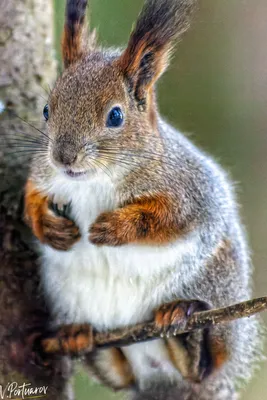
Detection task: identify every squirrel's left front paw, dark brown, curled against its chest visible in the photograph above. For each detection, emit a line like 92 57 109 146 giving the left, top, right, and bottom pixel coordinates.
42 203 81 250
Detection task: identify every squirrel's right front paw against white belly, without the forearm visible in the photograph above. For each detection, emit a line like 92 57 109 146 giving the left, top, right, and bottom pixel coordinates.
89 211 127 246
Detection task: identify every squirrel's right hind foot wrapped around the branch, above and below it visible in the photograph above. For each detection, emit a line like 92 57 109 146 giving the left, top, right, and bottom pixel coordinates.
155 300 228 382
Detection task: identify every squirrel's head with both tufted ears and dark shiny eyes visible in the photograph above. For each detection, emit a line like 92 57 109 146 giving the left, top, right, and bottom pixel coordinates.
44 0 195 177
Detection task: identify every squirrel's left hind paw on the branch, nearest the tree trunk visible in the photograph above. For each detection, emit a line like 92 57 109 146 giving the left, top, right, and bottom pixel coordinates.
33 324 94 360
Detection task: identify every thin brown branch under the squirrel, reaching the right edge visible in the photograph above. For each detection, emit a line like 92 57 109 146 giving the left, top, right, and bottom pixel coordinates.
95 297 267 348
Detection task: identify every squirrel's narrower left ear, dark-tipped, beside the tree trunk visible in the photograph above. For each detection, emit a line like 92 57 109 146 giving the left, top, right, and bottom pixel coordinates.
62 0 95 68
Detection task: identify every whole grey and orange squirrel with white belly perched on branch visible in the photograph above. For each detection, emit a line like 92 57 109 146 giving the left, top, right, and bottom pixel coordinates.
25 0 260 400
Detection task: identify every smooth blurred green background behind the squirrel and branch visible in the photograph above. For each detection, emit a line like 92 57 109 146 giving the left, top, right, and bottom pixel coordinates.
54 0 267 400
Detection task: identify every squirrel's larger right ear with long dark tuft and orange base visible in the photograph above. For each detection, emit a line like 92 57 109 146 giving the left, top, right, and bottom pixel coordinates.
117 0 196 108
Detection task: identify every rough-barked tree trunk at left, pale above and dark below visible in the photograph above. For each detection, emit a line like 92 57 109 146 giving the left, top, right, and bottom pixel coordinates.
0 0 72 400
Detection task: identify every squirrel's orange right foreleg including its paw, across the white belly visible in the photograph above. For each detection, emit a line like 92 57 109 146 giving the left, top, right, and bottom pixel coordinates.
89 195 180 246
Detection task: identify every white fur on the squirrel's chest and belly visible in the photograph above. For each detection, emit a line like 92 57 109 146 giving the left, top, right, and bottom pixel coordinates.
41 176 199 386
